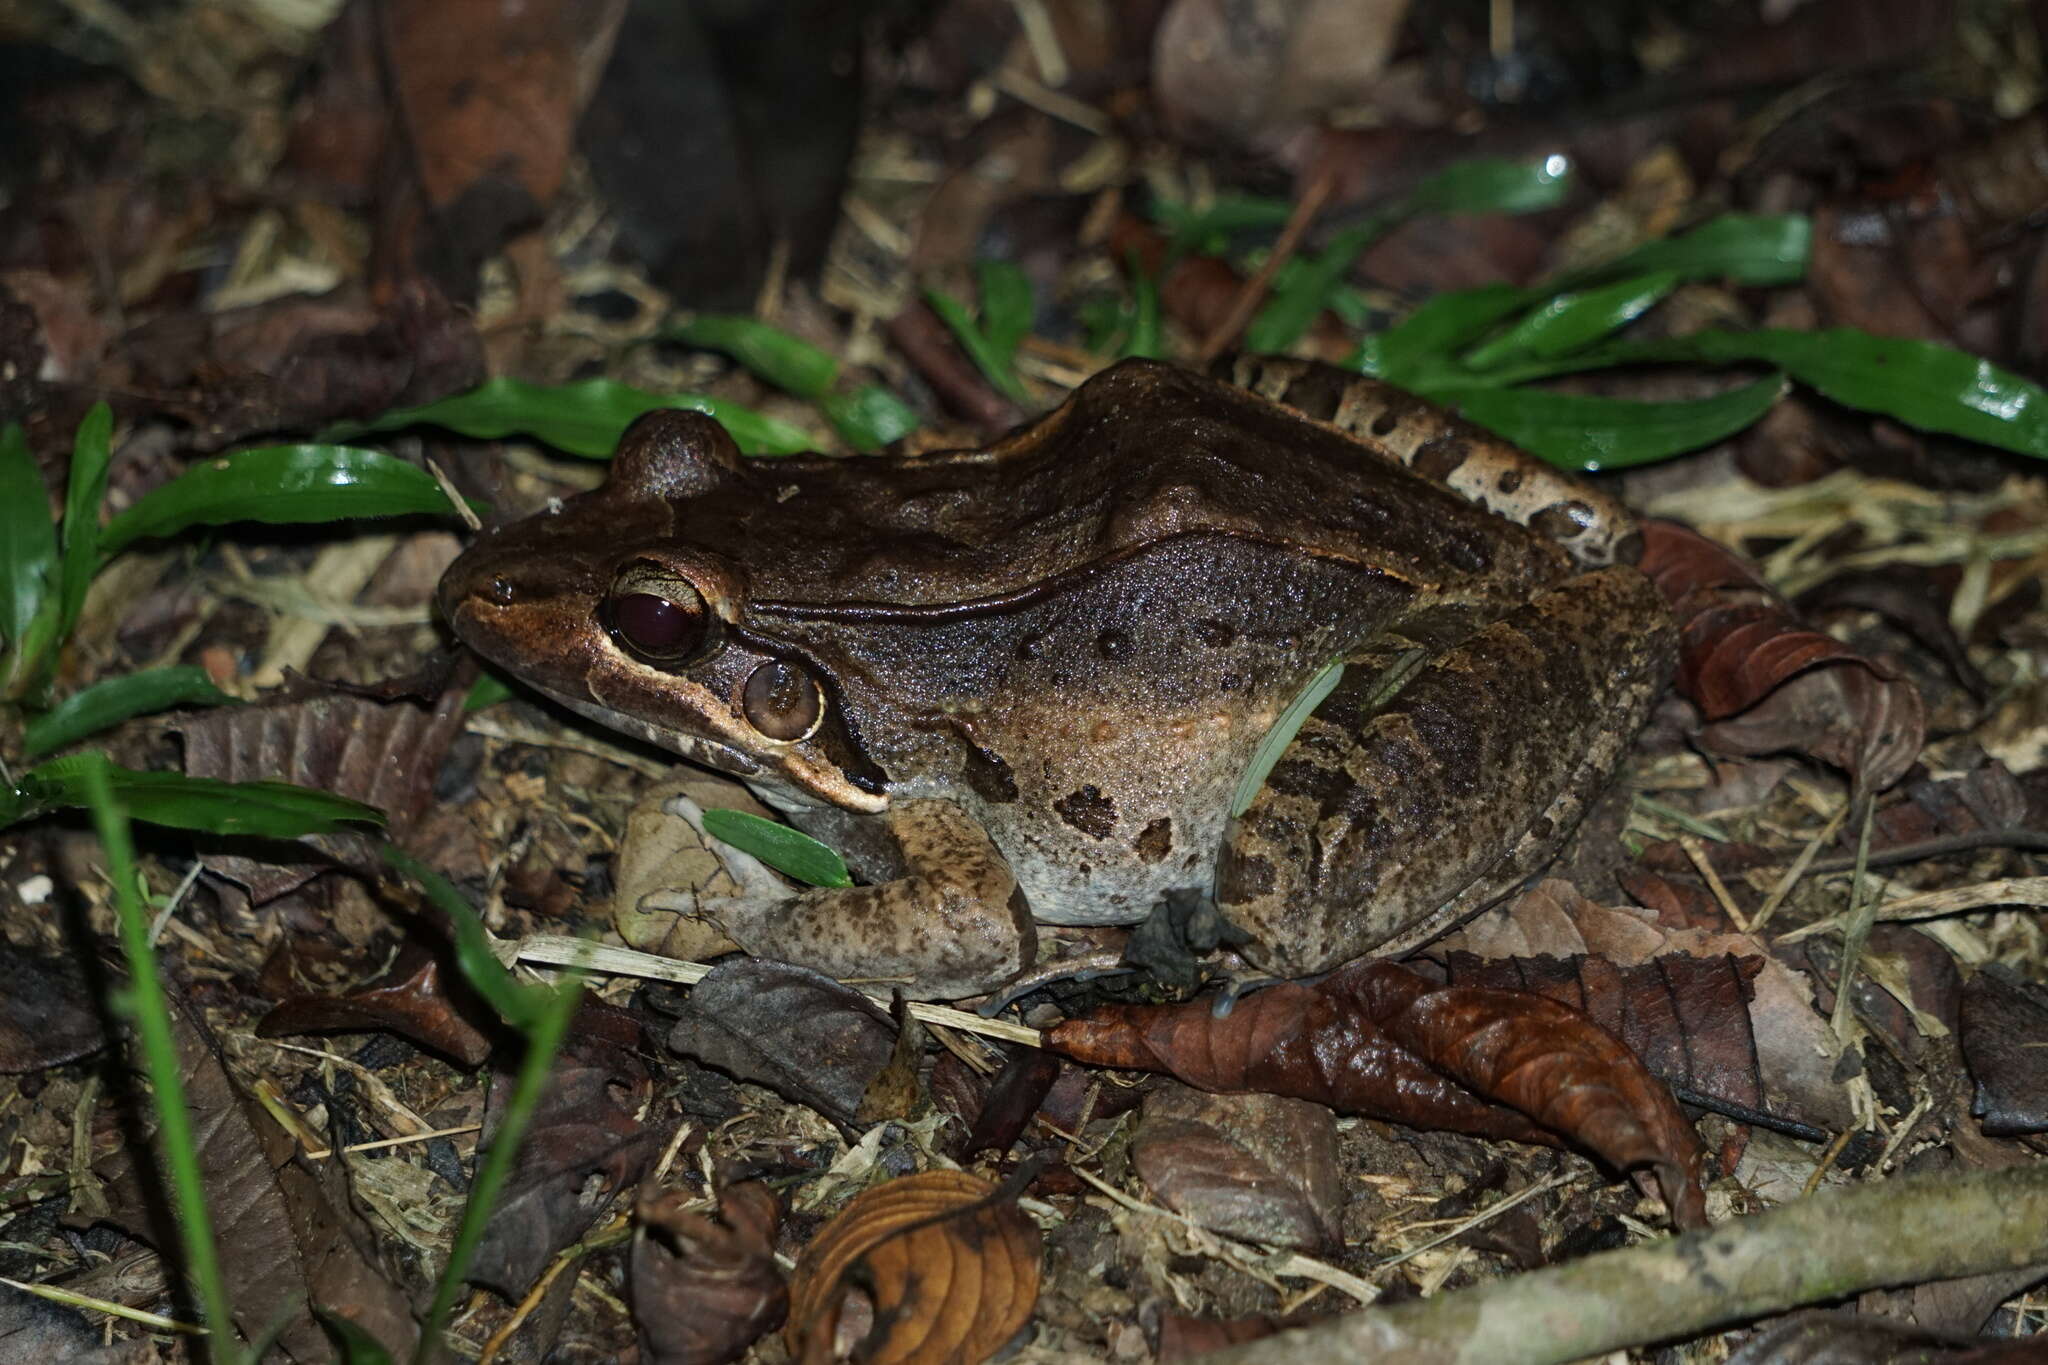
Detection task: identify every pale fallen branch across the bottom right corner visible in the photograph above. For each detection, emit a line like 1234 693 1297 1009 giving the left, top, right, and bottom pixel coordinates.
1202 1164 2048 1365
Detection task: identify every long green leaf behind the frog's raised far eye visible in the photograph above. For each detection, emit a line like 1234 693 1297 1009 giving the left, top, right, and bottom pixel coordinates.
328 375 813 460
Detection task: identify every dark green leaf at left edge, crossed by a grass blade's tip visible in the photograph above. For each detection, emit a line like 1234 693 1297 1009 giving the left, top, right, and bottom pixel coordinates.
0 751 385 839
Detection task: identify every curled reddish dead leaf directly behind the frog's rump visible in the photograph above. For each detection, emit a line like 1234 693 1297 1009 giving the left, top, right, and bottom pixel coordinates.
1640 520 1927 792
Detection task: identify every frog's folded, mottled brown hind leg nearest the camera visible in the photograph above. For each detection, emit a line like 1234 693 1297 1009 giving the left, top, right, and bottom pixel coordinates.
1217 567 1675 976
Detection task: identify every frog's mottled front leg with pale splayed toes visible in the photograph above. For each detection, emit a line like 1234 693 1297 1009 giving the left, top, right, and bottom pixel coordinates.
664 798 1036 1001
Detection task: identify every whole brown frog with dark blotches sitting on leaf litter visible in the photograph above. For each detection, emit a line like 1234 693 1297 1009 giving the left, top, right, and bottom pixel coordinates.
438 356 1675 999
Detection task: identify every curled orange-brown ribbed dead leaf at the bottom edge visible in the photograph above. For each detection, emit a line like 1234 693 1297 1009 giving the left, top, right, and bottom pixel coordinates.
788 1171 1038 1365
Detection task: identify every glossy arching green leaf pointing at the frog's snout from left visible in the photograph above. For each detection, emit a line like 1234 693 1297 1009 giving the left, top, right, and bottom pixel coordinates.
100 446 464 555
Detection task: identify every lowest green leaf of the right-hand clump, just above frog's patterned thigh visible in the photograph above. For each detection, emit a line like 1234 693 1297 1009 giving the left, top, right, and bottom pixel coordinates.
1427 377 1786 471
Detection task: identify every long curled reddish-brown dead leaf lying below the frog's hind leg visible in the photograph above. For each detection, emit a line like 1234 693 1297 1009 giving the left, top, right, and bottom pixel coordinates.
1044 962 1706 1228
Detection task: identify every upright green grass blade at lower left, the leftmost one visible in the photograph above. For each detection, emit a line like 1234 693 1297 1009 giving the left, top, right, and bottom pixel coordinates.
80 753 242 1365
